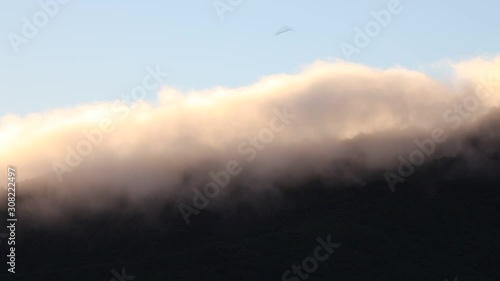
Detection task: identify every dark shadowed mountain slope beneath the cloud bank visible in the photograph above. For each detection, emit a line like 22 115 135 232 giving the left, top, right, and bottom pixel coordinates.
0 180 500 281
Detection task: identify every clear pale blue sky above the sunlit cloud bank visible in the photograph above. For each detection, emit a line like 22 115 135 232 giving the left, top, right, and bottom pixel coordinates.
0 0 500 116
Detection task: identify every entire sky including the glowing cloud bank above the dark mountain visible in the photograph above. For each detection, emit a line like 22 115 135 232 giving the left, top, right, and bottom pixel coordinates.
0 0 500 225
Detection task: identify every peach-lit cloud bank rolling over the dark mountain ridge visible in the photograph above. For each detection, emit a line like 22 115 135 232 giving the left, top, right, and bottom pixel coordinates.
0 57 500 220
